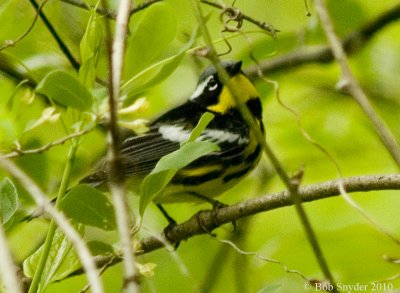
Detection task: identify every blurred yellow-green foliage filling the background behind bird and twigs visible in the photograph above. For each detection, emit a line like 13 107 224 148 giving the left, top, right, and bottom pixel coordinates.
0 0 400 292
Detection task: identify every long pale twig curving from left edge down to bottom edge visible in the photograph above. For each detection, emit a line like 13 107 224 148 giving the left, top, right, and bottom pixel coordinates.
0 158 103 293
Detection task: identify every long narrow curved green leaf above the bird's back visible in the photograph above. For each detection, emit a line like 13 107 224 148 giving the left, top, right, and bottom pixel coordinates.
122 25 198 95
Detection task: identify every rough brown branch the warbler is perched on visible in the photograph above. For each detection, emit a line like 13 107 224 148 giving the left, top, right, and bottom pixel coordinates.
67 174 400 275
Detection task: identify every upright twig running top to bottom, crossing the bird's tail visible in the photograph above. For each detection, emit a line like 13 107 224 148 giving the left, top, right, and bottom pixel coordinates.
103 0 139 292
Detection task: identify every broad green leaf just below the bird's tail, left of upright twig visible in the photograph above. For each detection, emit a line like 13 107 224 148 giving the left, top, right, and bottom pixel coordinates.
60 184 115 230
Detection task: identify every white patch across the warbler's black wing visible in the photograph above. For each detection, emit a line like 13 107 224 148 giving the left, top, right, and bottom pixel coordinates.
158 125 249 144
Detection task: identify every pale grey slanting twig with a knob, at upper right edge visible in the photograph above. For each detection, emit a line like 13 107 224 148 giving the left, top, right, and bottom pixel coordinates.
315 0 400 168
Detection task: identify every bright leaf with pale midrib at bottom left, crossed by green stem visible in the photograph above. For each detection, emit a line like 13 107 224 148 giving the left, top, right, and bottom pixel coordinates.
23 225 83 292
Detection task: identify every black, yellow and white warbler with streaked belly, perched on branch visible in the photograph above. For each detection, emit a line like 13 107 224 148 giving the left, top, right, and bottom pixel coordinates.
81 61 264 203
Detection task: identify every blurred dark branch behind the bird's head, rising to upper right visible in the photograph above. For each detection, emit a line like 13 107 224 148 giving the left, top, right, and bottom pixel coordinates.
245 4 400 78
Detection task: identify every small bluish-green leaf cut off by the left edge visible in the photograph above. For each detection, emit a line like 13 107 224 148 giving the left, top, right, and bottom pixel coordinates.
0 178 18 224
